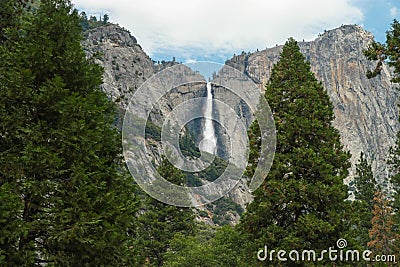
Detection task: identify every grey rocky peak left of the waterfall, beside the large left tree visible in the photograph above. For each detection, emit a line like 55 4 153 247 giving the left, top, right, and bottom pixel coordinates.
83 24 155 109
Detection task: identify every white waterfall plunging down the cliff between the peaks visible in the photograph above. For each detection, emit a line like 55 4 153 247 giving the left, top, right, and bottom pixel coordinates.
200 82 217 154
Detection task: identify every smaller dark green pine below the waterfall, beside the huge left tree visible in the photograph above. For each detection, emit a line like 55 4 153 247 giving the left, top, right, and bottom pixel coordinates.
139 159 195 266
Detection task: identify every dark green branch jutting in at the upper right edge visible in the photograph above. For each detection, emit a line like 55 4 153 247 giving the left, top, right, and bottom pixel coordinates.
364 20 400 83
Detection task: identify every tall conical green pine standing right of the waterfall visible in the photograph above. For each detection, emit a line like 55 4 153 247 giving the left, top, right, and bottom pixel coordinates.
239 39 349 256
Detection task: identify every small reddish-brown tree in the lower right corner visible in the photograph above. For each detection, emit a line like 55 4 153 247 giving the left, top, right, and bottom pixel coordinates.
368 191 395 260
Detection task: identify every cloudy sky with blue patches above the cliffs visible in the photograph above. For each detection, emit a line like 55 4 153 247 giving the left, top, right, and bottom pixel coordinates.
72 0 400 63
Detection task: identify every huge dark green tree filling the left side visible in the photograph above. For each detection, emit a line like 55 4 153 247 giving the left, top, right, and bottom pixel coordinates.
0 0 137 266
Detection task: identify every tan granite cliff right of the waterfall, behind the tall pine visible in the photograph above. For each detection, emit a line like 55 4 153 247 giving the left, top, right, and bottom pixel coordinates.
226 25 399 188
